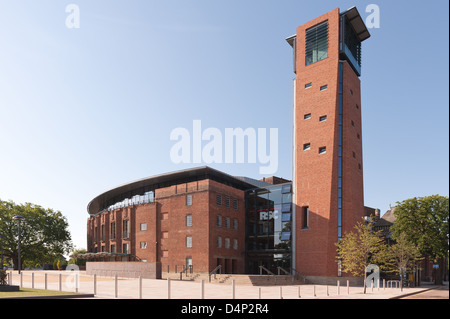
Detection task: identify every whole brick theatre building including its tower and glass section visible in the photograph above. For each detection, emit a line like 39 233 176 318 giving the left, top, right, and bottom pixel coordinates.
87 7 370 281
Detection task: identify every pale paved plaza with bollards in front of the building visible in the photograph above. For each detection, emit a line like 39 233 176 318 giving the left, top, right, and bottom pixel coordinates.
5 271 448 299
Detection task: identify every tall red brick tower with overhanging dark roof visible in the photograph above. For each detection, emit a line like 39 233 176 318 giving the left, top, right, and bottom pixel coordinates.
287 7 370 279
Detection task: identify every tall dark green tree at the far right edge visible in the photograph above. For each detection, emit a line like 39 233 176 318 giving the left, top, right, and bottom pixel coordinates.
391 195 449 284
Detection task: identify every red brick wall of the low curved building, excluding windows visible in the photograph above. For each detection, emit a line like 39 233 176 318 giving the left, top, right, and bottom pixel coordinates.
87 180 245 273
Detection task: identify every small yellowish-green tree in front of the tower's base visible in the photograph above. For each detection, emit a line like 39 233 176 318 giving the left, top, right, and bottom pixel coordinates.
336 222 388 293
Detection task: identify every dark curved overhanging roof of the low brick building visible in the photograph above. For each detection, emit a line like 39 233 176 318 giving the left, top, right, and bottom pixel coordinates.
87 166 255 215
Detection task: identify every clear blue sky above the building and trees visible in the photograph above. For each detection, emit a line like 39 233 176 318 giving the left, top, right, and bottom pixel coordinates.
0 0 449 248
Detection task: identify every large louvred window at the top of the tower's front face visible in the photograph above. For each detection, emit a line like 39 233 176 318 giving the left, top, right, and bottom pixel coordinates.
305 21 328 65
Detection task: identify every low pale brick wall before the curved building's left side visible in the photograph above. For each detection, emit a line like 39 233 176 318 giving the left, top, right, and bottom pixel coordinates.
86 261 161 279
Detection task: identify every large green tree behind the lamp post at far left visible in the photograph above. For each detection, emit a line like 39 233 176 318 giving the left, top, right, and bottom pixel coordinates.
0 200 72 269
